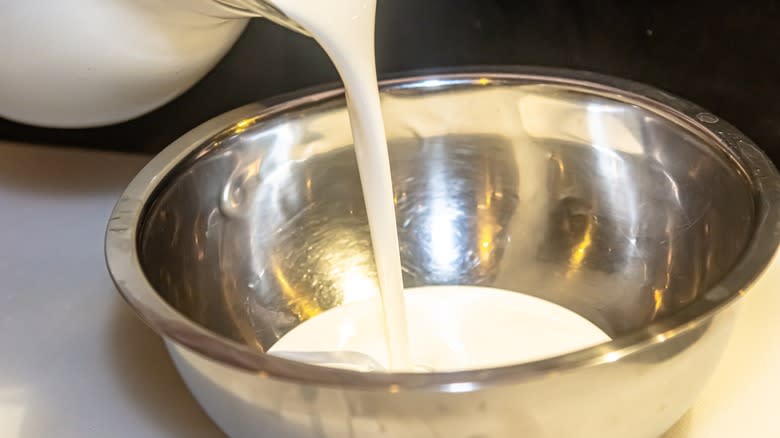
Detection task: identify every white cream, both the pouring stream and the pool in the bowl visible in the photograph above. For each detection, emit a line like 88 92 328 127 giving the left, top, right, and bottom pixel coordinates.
262 0 609 371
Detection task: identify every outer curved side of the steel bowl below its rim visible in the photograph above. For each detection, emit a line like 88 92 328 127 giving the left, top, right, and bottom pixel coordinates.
166 306 738 438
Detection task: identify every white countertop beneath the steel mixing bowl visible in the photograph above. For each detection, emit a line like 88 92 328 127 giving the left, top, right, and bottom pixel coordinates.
0 143 780 438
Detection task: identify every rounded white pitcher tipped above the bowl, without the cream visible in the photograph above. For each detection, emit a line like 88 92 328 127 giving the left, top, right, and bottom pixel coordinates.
0 0 299 128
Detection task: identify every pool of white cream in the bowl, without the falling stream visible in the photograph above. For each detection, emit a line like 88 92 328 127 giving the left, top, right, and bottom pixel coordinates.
269 286 610 371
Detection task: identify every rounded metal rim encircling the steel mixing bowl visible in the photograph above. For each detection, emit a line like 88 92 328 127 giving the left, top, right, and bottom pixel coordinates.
105 66 780 392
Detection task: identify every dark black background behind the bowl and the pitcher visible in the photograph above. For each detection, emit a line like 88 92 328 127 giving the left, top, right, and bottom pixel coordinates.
0 0 780 162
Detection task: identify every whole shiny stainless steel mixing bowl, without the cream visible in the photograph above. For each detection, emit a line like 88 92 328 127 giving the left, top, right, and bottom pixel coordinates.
106 69 780 438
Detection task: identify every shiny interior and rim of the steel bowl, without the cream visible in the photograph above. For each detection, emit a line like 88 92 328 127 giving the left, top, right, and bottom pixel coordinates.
107 71 778 385
